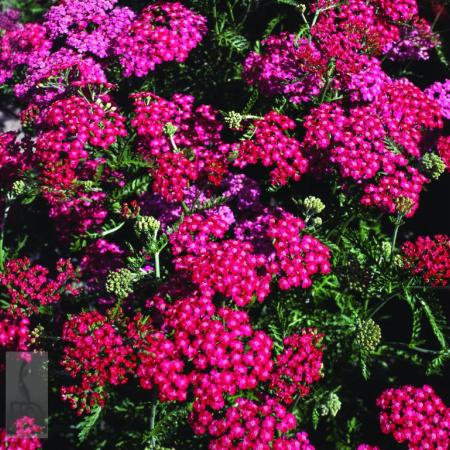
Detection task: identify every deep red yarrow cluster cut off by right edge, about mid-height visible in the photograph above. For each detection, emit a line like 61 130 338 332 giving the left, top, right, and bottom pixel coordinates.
402 234 450 286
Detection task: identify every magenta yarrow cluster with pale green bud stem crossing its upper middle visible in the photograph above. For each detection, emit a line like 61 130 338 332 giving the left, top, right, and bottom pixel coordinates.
131 92 229 201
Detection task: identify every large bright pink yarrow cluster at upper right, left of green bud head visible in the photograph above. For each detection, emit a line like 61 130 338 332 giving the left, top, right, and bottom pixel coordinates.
303 79 442 217
